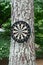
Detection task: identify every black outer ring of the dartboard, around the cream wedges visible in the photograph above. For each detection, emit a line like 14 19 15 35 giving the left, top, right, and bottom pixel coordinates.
11 21 31 43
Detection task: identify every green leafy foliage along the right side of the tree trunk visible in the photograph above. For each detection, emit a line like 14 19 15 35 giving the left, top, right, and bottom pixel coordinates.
34 0 43 58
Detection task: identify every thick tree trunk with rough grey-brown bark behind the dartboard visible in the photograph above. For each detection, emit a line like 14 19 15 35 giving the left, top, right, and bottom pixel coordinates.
9 0 35 65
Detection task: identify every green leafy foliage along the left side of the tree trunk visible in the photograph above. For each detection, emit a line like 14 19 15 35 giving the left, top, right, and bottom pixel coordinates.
0 2 11 59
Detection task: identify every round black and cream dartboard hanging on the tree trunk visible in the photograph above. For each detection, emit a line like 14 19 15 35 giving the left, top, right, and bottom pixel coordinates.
11 21 31 43
